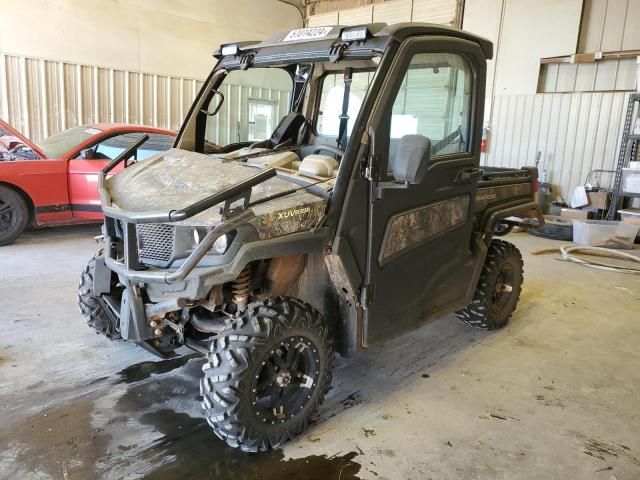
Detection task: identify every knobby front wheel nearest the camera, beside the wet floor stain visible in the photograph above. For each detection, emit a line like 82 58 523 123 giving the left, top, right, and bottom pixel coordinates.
200 297 334 452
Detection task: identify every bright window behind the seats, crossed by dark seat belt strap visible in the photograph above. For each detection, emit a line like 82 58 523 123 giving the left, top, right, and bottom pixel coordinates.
316 72 373 138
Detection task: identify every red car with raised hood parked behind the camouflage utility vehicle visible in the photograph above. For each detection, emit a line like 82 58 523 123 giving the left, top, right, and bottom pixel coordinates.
0 120 175 245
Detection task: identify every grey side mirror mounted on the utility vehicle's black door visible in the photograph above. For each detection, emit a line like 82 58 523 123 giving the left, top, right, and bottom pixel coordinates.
389 135 431 185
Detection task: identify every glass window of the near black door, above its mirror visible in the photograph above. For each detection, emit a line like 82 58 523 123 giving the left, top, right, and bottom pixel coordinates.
389 53 472 159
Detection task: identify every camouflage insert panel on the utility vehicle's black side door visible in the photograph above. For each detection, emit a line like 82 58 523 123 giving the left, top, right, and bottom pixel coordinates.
380 195 469 263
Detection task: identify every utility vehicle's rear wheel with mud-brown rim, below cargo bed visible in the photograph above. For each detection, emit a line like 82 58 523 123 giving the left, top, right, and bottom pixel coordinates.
456 240 524 330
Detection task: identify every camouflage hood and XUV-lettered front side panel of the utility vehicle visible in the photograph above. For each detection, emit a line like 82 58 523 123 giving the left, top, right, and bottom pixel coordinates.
106 148 333 238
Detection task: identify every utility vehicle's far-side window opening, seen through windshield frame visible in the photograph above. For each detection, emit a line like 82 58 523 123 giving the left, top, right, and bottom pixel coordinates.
205 68 293 147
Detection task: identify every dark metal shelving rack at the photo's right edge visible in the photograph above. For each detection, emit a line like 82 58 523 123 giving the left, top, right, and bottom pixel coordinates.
607 93 640 220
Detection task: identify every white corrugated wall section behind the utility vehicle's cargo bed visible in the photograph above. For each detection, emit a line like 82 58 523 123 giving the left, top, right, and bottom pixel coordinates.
482 92 629 199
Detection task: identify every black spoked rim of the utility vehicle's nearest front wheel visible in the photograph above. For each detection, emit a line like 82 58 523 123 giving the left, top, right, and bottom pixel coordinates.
251 336 320 424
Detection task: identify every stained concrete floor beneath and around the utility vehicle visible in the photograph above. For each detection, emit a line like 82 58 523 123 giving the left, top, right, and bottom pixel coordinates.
0 226 640 480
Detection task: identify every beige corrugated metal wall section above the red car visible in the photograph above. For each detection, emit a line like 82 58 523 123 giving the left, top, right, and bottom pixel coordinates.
0 53 202 142
